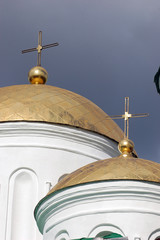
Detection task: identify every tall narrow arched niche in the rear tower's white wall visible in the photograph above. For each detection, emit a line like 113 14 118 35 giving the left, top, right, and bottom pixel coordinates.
6 168 38 240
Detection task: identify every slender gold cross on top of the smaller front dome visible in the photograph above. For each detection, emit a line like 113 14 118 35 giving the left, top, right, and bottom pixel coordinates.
108 97 149 139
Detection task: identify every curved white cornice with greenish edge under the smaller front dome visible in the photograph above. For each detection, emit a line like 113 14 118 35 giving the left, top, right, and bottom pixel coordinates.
36 181 160 232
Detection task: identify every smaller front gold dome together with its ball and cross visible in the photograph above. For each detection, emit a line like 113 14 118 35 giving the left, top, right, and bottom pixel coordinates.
48 98 156 195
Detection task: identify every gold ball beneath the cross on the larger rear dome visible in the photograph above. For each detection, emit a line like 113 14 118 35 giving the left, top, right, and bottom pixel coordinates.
28 66 48 84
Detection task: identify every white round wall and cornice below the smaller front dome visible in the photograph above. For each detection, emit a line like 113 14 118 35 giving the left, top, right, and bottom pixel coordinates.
36 181 160 240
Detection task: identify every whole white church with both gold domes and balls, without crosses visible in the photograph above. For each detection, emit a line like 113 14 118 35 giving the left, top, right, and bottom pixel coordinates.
0 59 160 240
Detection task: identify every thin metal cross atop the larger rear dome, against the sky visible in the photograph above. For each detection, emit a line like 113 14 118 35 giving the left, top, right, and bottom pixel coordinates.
22 31 59 66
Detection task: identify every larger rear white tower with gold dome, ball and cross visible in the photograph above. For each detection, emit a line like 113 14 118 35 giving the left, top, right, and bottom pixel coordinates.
0 33 123 240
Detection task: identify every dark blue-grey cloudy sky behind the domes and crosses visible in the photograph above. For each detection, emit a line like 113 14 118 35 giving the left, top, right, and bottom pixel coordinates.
0 0 160 162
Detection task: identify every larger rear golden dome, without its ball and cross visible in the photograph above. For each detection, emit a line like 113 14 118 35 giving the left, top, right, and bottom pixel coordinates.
0 84 123 142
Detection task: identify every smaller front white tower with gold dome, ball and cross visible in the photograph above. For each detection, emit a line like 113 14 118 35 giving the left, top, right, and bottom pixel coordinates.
35 99 160 240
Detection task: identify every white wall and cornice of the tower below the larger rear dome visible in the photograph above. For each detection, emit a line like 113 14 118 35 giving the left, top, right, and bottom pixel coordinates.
0 122 118 240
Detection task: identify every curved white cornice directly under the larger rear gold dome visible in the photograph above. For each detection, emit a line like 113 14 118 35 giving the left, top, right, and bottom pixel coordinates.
0 122 119 160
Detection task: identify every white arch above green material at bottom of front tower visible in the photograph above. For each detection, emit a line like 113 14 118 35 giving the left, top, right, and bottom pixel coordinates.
88 224 125 238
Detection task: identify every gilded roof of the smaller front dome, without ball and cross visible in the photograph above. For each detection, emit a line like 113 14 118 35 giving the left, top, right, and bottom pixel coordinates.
48 155 160 195
